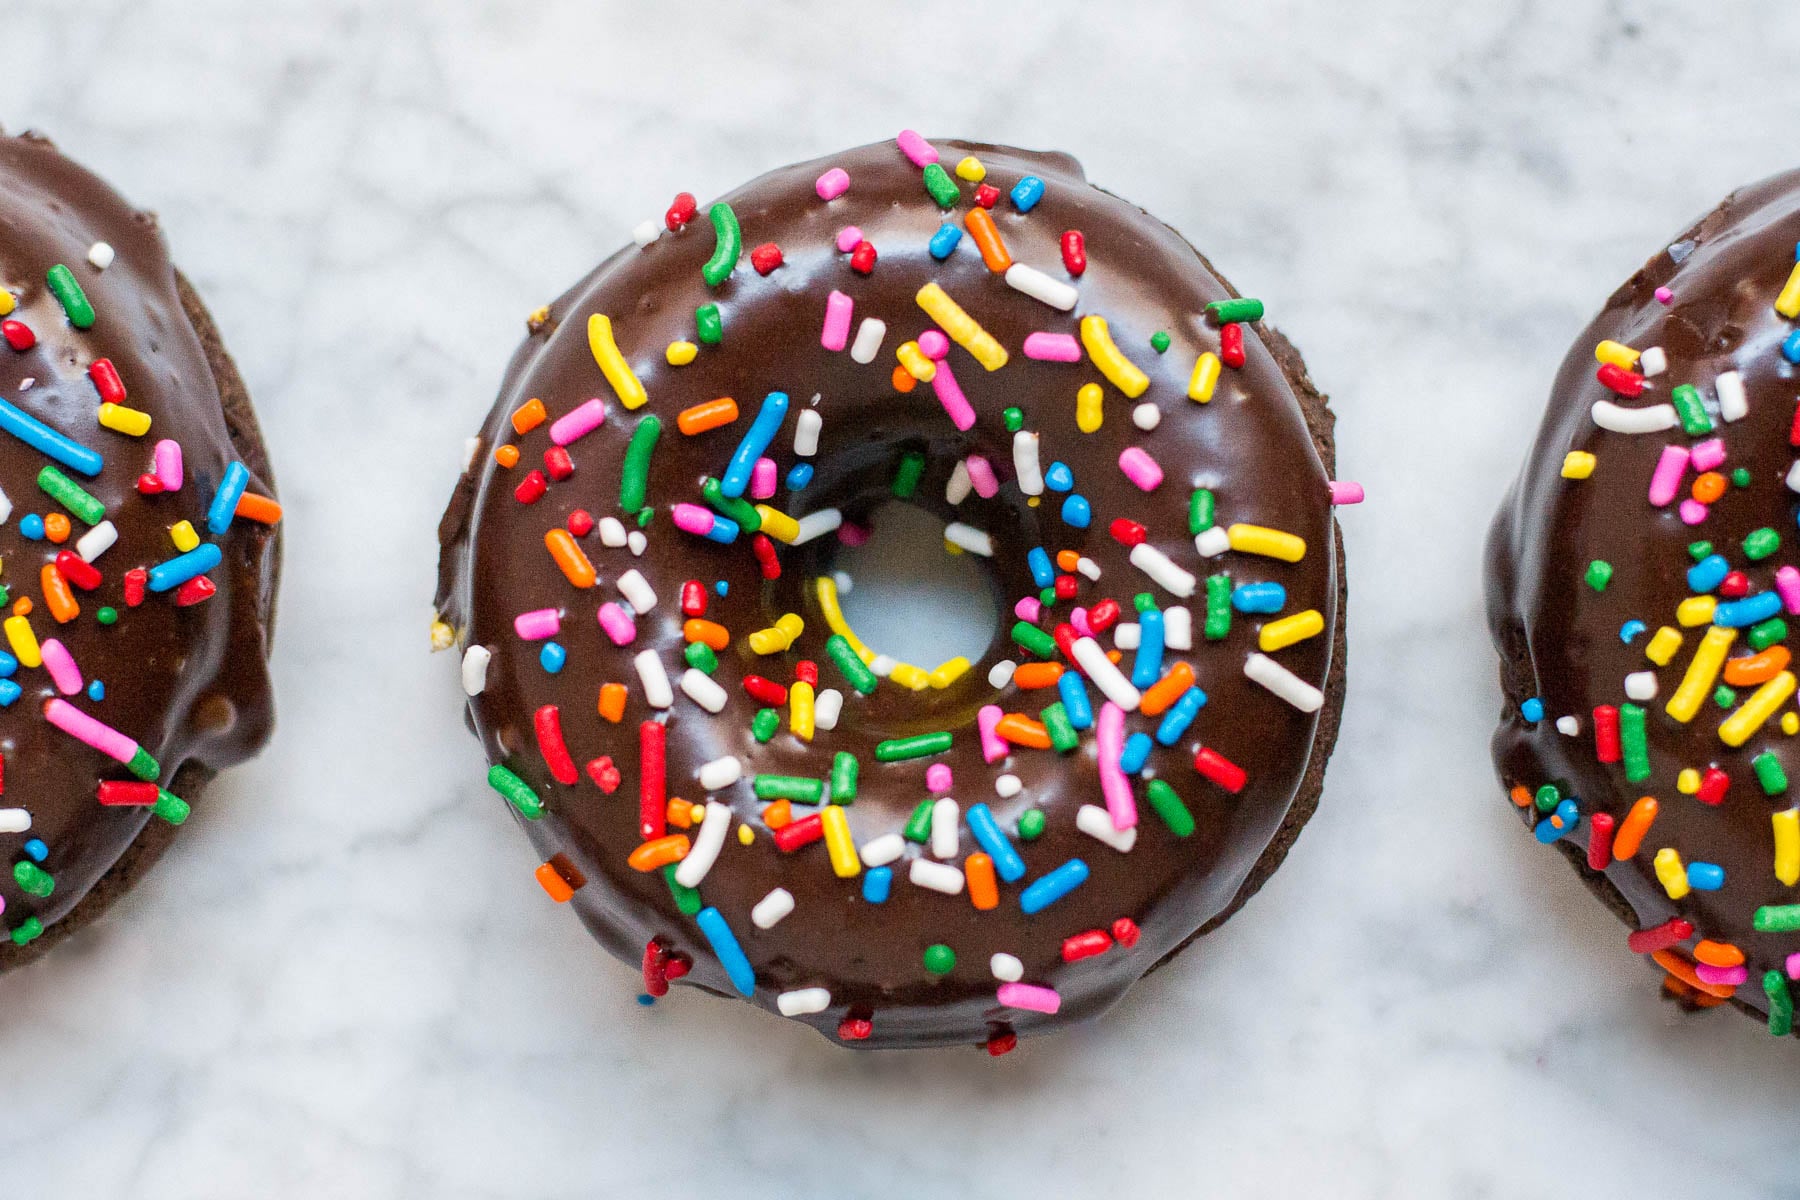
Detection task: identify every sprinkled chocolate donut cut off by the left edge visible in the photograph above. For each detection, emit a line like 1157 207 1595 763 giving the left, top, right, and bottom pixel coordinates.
0 135 281 970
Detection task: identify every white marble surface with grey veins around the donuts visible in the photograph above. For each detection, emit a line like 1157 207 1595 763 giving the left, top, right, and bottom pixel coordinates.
0 0 1800 1200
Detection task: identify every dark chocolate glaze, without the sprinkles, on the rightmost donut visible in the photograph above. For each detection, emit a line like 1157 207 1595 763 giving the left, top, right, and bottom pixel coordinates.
1487 171 1800 1036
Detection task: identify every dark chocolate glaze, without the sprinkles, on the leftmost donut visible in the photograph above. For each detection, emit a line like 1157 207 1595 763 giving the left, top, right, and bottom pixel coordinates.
0 135 277 968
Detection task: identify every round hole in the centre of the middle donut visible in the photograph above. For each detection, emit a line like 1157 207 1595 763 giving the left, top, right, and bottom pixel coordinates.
832 500 999 669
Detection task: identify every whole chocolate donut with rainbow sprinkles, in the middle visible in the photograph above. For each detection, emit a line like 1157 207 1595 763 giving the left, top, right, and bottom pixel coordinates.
432 131 1359 1052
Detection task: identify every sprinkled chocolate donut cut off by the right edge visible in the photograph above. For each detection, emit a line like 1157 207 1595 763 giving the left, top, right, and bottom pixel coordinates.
1487 171 1800 1034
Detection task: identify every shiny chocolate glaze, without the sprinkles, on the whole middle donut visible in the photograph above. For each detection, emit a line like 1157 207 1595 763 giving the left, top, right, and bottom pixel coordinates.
437 142 1339 1047
